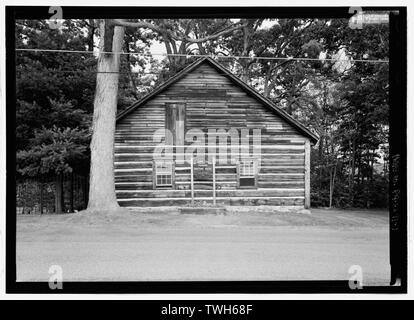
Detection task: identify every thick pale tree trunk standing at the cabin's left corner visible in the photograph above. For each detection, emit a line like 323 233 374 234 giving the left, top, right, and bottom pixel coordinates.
87 20 124 211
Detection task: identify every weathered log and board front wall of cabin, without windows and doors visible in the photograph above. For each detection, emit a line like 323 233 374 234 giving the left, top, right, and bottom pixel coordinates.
115 64 309 207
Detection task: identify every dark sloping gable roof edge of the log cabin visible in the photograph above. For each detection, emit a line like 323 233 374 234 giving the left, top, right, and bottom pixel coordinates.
116 57 319 143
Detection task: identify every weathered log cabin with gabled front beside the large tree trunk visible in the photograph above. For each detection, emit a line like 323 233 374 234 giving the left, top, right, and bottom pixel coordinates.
114 58 318 208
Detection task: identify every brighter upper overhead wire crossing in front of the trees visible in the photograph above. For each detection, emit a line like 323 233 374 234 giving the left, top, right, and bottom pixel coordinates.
16 48 389 63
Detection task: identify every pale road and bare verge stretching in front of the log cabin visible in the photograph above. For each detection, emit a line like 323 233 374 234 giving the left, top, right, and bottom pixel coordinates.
17 211 390 285
